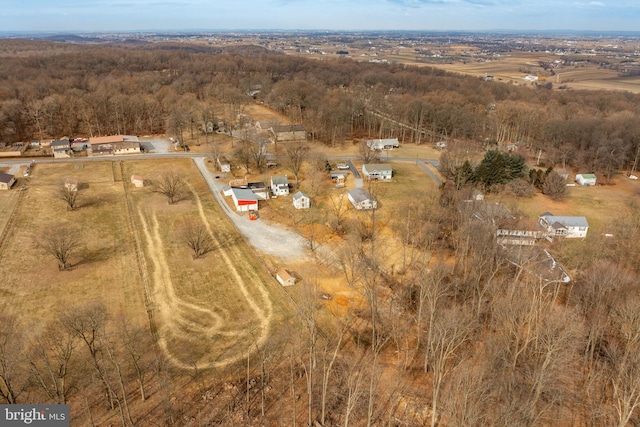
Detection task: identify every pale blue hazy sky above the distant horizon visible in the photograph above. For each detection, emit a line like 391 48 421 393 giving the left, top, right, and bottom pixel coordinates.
0 0 640 32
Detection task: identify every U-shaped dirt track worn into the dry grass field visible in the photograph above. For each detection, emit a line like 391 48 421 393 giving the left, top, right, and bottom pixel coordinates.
138 184 273 369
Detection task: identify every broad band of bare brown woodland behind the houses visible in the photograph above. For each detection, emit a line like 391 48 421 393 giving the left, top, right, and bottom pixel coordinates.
0 40 640 176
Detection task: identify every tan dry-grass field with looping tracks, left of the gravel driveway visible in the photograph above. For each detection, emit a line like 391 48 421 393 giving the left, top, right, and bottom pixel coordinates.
0 159 291 369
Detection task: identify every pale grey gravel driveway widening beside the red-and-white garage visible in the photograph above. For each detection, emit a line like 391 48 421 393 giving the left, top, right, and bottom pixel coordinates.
193 157 308 259
